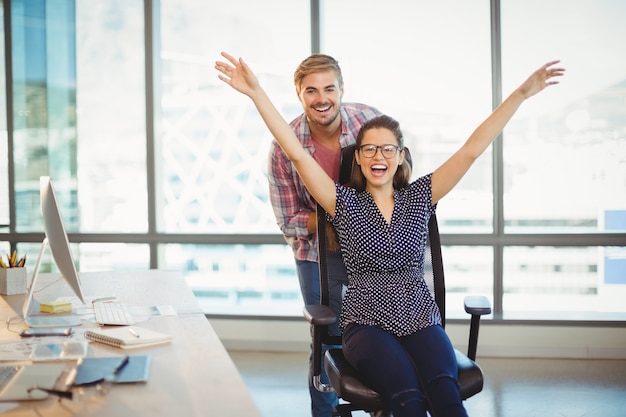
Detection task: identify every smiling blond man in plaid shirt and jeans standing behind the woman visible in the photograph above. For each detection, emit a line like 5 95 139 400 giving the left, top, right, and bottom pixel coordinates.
268 54 381 417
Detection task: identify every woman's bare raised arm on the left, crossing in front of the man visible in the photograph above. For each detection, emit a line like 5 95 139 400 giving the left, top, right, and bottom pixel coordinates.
215 52 336 214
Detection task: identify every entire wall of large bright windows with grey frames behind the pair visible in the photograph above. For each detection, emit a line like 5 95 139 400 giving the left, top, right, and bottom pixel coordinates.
0 0 626 322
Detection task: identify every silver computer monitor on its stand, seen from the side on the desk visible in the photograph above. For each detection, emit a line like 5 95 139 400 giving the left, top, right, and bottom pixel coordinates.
23 177 85 327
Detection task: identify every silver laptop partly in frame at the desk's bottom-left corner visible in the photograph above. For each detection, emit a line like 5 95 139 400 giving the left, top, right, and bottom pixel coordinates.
0 362 75 401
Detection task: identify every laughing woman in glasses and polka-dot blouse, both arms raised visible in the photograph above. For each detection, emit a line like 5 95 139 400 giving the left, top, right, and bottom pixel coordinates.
215 53 564 417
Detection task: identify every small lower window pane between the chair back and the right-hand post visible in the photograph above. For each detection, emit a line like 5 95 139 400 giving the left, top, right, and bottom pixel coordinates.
442 246 493 319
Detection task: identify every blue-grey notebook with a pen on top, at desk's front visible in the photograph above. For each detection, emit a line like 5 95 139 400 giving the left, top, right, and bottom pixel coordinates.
74 355 151 386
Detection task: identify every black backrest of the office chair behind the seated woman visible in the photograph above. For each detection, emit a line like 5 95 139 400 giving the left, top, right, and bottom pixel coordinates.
317 145 446 345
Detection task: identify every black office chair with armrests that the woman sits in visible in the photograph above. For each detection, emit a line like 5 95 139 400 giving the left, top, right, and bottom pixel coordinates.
303 145 491 417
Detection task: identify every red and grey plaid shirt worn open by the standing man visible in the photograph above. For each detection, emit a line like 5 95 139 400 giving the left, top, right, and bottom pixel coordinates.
267 103 382 262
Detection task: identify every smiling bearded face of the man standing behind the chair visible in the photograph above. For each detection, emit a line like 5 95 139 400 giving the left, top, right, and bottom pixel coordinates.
298 71 343 128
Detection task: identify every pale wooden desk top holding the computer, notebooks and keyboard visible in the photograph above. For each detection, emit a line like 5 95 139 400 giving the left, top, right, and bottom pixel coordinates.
0 270 260 417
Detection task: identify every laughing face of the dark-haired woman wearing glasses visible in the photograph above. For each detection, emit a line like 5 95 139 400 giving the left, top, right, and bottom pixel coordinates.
355 127 404 188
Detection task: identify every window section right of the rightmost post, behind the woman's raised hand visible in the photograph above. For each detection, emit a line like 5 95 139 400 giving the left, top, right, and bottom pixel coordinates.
501 0 626 318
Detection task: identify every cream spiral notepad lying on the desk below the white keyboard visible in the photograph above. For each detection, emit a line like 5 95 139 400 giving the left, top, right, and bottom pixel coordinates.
85 326 172 349
